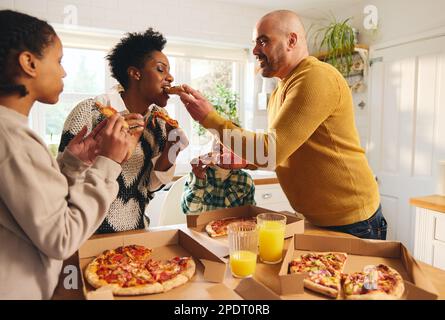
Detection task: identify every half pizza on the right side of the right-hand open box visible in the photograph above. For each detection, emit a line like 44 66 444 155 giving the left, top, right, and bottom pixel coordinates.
343 264 405 300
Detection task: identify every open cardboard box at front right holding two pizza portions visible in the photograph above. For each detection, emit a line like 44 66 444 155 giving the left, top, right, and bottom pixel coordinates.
278 234 438 300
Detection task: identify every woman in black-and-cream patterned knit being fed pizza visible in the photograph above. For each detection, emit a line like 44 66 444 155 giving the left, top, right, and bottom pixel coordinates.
59 28 188 233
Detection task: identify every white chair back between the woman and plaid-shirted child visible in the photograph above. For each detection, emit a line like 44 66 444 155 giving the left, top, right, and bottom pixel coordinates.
159 174 189 226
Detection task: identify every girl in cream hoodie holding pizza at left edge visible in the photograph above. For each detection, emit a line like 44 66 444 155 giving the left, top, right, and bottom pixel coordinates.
0 10 136 299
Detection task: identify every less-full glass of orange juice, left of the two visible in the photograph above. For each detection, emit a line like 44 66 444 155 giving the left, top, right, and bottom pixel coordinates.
227 221 258 278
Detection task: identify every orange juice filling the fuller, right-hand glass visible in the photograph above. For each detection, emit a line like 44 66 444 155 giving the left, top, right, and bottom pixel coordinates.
259 221 285 263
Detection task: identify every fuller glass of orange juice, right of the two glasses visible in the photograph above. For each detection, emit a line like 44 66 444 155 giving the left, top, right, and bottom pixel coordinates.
257 213 286 264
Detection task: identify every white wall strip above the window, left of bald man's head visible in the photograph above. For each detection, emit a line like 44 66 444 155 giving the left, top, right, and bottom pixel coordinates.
0 0 265 48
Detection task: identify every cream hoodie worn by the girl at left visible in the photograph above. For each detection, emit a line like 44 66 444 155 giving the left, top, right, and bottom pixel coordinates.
0 106 121 300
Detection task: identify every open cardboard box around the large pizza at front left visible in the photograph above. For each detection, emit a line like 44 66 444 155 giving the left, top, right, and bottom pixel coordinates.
79 229 242 300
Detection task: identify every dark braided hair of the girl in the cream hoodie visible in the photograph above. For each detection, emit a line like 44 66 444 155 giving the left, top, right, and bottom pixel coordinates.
0 10 56 97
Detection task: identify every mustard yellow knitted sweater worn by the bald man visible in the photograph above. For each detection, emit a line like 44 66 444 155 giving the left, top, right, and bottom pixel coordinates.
201 57 380 226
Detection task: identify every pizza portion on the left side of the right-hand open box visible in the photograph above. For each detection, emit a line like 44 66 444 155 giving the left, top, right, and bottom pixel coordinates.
289 252 347 298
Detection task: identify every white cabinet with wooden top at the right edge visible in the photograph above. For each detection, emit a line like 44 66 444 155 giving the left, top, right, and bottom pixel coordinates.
410 195 445 270
